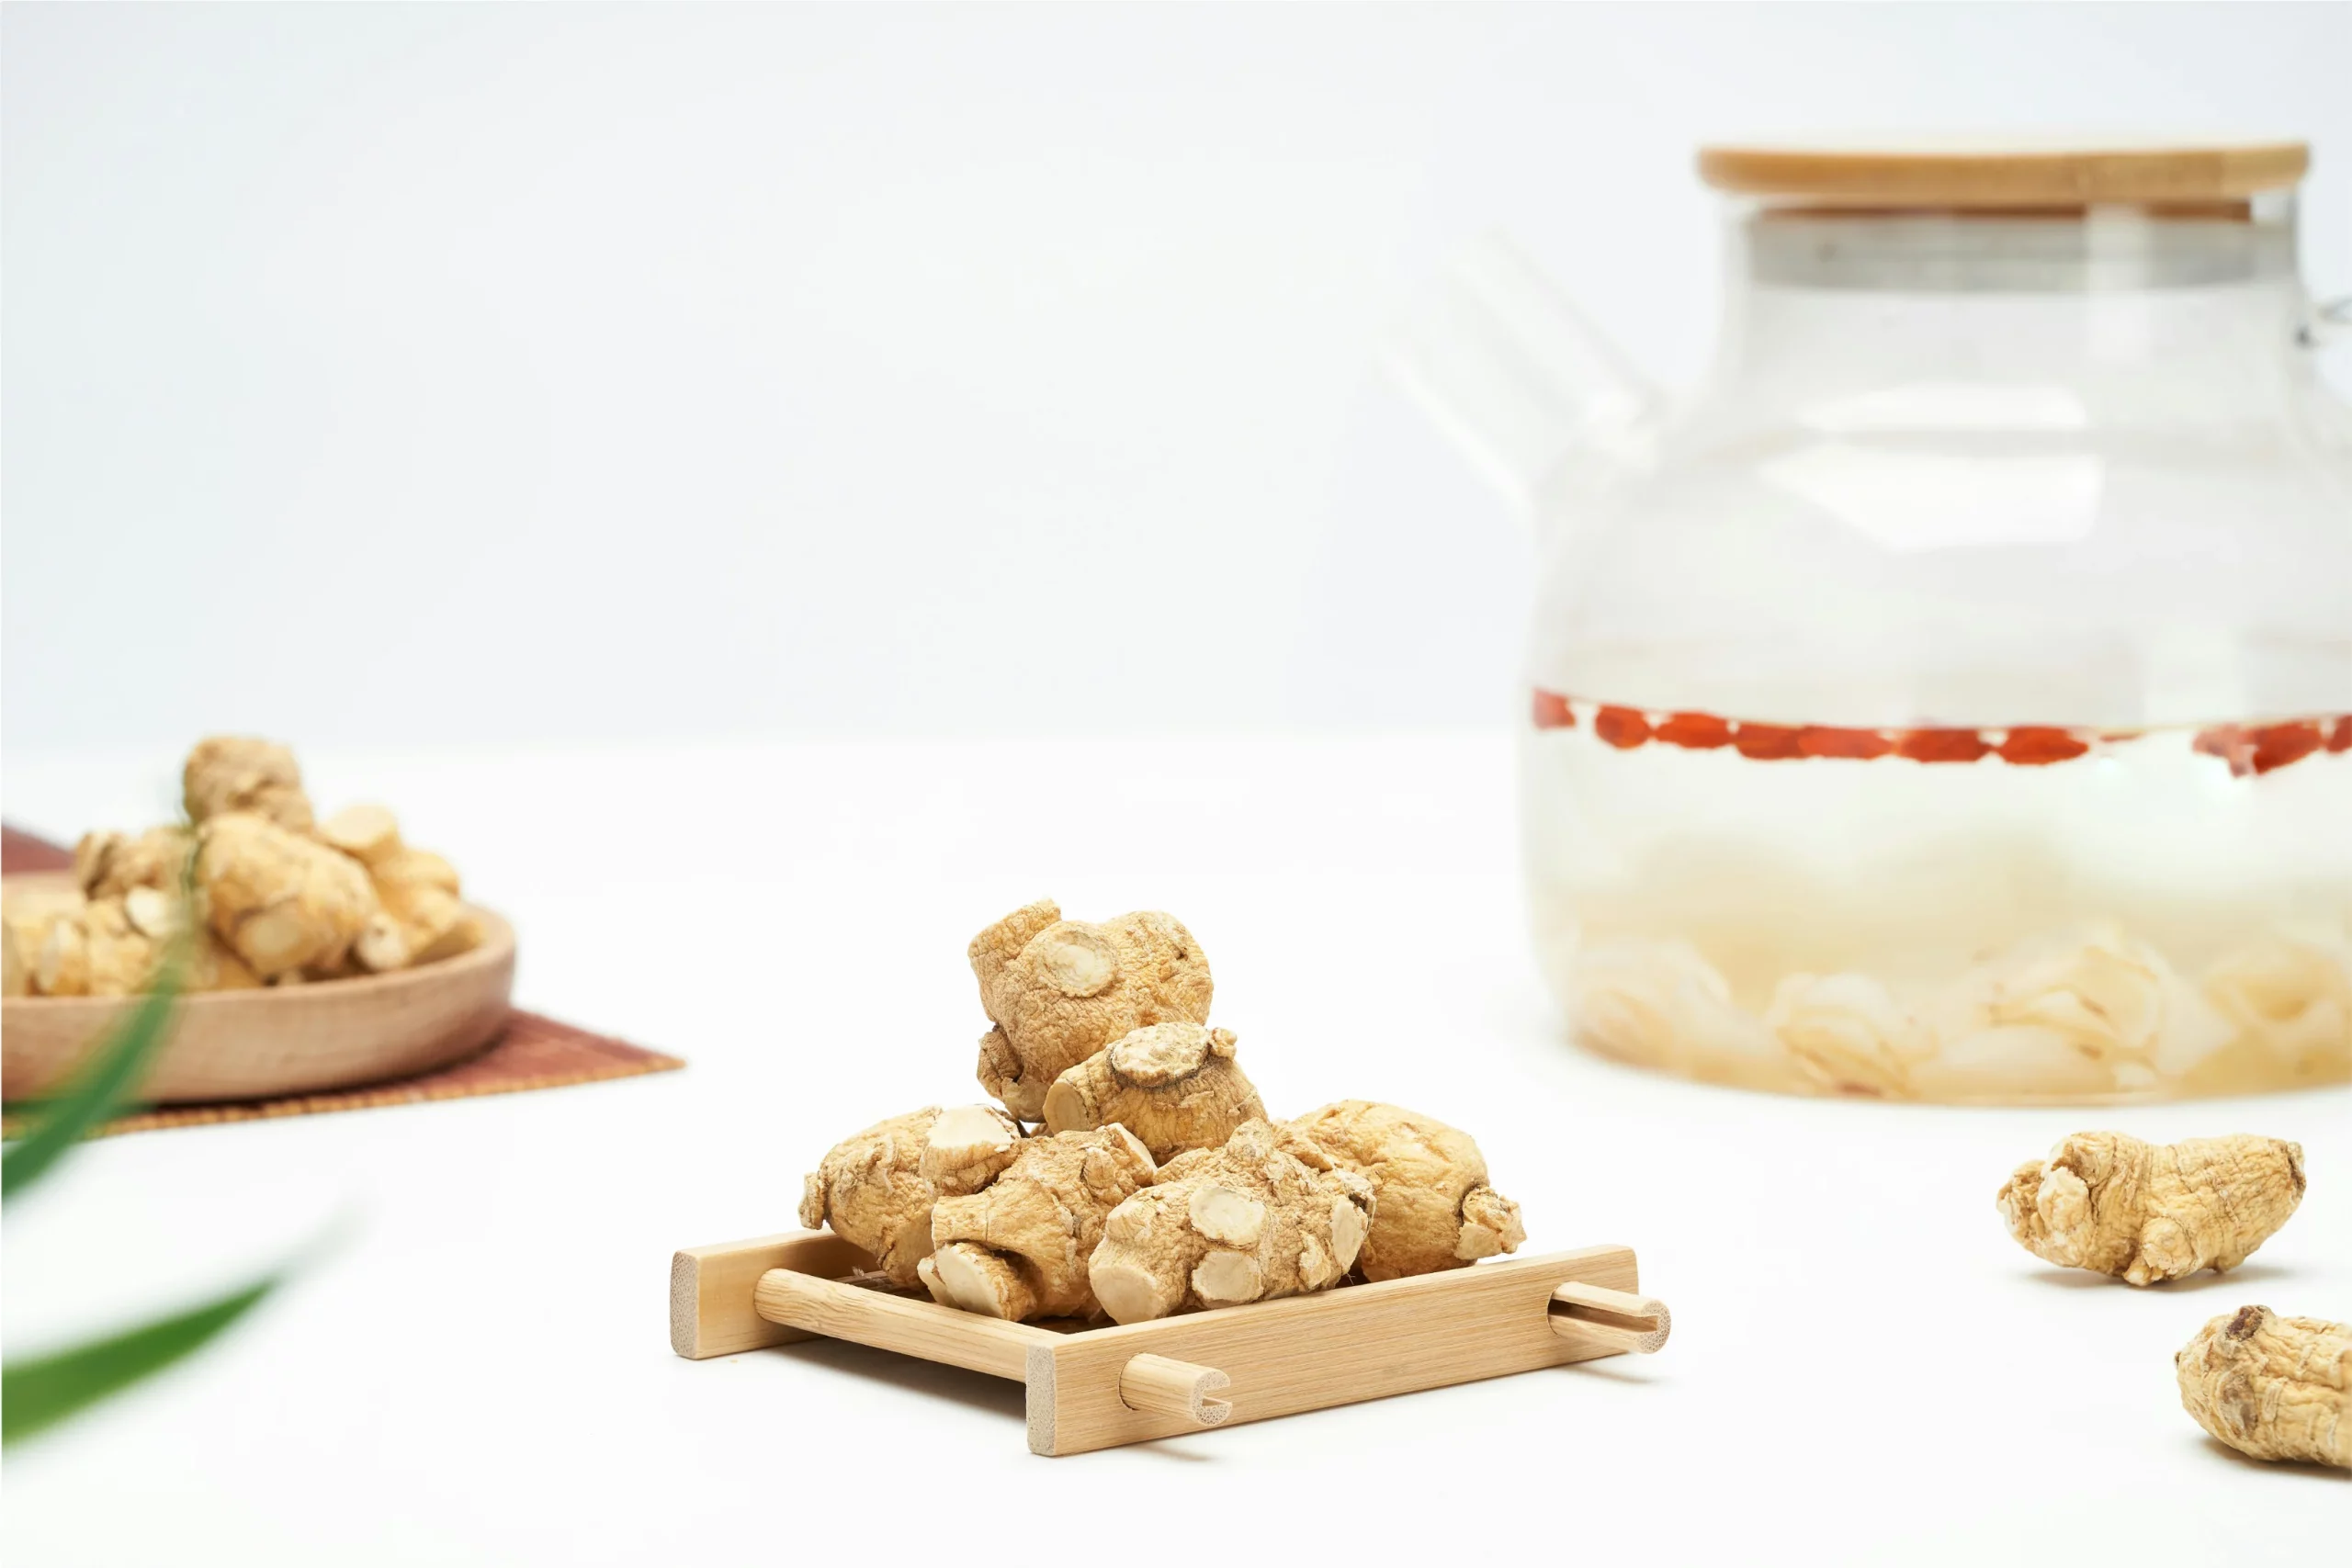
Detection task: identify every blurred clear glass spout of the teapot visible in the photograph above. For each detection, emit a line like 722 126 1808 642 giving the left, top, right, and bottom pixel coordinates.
1385 235 1658 513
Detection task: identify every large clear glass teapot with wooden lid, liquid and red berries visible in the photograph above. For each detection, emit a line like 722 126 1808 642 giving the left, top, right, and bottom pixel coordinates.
1393 143 2352 1102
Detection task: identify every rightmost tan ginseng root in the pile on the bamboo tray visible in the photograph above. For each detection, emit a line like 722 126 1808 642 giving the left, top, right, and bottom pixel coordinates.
1289 1100 1526 1279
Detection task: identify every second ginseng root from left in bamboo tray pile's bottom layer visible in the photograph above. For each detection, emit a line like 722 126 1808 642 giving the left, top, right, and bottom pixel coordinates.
920 1126 1155 1321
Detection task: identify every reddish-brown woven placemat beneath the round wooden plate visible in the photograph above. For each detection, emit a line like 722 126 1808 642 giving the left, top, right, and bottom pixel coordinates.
0 825 684 1138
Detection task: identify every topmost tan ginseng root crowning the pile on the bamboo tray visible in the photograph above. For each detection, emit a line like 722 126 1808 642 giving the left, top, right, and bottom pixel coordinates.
969 898 1211 1122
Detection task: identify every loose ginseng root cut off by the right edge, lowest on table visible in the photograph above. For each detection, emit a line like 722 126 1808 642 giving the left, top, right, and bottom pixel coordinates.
2173 1307 2352 1470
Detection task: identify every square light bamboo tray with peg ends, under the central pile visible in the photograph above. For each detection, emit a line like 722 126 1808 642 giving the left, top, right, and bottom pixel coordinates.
671 1229 1670 1455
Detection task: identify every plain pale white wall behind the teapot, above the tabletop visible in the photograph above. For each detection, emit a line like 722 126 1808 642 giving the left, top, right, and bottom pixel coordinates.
0 5 2352 755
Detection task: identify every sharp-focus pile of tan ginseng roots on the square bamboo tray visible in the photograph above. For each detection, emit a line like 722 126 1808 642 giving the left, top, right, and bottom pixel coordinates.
799 900 1526 1324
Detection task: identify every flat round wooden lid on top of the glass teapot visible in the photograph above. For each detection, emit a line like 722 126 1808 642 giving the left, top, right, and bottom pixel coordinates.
1698 139 2312 207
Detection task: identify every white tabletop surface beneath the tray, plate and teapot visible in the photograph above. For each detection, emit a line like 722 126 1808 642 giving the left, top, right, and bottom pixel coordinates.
0 739 2352 1568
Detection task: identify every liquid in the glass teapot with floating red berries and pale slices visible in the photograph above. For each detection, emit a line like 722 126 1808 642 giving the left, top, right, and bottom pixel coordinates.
1521 694 2352 1102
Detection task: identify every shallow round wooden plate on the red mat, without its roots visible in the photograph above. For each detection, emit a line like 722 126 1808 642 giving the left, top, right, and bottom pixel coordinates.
0 872 515 1105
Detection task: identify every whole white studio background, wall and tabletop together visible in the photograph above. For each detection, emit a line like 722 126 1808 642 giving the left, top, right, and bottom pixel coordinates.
0 5 2352 1565
